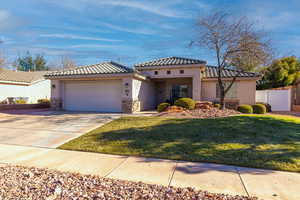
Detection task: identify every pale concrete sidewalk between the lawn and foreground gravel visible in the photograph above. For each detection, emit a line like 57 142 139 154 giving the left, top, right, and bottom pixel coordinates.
0 144 300 200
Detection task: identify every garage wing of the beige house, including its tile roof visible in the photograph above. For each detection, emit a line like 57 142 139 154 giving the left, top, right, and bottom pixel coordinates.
46 61 136 113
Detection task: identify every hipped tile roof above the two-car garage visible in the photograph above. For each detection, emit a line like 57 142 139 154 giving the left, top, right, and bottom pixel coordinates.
45 62 133 77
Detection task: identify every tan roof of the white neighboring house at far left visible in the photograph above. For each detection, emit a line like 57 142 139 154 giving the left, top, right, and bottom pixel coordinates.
0 68 47 84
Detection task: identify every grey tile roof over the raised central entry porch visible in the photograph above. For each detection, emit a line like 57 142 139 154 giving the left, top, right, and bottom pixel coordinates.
134 56 206 67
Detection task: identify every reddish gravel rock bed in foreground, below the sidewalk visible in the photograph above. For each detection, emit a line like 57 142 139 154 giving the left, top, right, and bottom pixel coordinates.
0 165 257 200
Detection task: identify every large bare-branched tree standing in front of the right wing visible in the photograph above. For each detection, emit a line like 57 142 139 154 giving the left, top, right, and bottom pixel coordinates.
191 12 271 109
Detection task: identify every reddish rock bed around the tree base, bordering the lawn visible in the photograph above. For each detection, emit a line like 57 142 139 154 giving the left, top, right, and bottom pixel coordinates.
157 108 241 119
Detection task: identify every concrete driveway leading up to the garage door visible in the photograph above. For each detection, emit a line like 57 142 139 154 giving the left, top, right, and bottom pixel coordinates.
0 110 120 148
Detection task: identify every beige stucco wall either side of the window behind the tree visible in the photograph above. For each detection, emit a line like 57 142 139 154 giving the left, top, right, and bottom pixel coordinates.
201 80 256 104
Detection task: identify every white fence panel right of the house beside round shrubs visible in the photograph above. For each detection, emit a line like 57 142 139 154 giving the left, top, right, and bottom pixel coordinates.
256 89 292 111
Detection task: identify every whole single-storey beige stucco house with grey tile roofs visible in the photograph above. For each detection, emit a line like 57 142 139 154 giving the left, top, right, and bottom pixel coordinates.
46 57 260 113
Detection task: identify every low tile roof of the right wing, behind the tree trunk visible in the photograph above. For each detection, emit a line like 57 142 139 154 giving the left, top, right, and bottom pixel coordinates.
204 65 260 78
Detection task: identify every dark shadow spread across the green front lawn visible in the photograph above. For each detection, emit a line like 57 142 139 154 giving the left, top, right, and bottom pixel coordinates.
97 116 300 173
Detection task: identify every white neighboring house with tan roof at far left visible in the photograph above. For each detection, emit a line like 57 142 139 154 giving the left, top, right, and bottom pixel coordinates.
0 68 51 103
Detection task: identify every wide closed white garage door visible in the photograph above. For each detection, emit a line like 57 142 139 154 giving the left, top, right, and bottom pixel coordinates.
64 80 122 112
